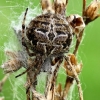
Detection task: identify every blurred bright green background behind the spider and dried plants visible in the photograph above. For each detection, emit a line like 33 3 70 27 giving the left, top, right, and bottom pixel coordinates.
0 0 100 100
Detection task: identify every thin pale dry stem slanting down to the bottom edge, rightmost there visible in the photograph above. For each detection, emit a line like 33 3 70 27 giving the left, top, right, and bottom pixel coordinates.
68 60 83 100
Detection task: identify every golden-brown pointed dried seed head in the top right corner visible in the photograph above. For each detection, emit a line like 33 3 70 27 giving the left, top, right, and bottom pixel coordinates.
84 0 100 24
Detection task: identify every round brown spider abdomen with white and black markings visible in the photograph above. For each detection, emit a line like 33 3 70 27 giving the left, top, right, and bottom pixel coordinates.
26 14 72 55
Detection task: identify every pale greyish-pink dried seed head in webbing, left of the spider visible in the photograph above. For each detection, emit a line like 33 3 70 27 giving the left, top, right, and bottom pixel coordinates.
1 51 25 73
